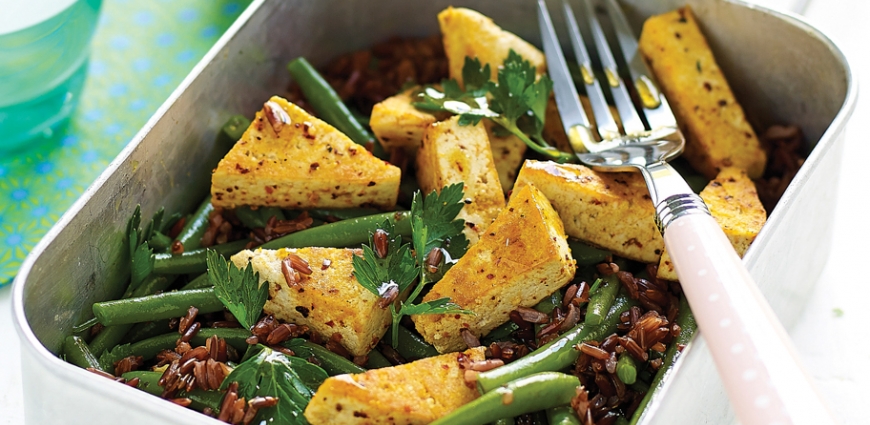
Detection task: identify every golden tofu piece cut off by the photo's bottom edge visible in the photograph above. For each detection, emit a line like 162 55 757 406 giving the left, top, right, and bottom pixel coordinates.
305 347 484 425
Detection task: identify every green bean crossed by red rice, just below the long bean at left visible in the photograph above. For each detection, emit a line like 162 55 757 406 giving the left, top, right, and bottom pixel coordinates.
100 328 251 366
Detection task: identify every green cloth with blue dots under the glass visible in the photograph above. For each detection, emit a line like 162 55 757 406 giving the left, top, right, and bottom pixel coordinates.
0 0 250 288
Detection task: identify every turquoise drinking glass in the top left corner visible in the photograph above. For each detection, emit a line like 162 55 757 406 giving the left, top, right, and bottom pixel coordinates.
0 0 102 152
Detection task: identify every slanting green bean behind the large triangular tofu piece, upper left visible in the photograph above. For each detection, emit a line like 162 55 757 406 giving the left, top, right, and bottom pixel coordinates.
287 57 375 147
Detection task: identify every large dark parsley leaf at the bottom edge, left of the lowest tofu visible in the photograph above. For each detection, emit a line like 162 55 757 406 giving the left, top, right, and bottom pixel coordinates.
221 346 327 425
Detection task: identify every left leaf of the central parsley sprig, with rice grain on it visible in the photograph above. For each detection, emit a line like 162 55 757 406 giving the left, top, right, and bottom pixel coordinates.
353 220 418 296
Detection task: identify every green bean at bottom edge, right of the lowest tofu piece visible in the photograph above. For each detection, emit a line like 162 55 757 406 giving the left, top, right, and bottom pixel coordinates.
432 372 580 425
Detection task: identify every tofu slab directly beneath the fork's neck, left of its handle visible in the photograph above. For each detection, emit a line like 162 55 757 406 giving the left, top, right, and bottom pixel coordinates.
514 160 664 263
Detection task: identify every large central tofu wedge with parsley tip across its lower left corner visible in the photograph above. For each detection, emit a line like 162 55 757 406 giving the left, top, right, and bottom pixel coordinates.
412 184 576 353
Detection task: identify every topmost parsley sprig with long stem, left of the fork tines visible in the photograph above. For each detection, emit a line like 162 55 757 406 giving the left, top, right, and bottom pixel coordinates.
413 50 574 162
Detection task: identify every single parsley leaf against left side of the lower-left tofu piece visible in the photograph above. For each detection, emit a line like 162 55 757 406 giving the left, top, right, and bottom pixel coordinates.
206 250 269 329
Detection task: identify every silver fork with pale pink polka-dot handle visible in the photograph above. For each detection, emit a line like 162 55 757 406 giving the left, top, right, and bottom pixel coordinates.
538 0 836 425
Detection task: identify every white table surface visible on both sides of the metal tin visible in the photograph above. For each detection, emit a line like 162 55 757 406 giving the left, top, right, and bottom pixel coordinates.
0 0 870 425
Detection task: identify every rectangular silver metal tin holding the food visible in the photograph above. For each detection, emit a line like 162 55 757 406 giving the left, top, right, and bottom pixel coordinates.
13 0 856 424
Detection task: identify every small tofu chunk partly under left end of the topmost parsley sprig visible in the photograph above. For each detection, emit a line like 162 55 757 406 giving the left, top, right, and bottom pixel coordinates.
369 87 449 154
